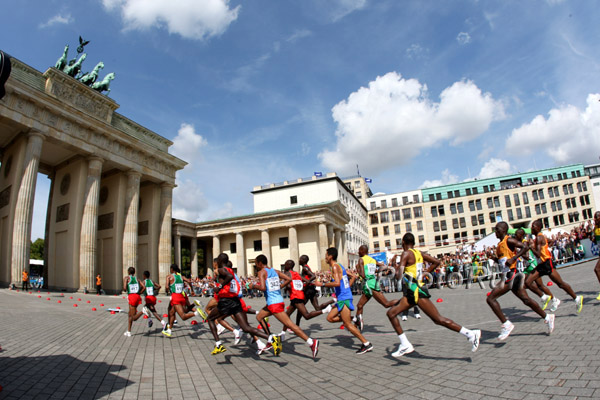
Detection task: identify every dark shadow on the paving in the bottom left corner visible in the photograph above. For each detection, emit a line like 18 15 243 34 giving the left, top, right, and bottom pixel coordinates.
0 355 133 399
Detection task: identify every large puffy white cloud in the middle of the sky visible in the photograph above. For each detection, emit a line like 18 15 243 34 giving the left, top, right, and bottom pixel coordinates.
319 72 504 174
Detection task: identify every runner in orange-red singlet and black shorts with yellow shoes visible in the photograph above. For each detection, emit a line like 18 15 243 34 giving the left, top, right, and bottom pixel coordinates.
525 219 583 314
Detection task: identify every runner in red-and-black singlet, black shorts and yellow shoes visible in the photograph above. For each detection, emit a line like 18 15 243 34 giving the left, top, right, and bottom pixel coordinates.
208 253 274 355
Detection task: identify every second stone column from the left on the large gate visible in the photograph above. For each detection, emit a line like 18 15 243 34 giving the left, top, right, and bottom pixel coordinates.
79 157 104 292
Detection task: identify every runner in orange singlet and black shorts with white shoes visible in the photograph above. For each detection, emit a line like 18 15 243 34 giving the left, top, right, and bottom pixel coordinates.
486 221 554 340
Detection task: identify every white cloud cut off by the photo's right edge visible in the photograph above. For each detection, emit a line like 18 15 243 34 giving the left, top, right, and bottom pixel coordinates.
506 94 600 164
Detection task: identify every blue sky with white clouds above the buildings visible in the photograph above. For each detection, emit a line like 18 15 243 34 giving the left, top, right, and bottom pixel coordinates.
0 0 600 238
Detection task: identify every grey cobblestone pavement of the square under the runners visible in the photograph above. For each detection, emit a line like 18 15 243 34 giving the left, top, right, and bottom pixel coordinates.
0 262 600 399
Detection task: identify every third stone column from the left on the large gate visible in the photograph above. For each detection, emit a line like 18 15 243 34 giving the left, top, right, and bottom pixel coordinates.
123 171 142 276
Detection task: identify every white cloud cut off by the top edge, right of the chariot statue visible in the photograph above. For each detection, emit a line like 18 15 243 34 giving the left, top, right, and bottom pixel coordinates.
102 0 241 40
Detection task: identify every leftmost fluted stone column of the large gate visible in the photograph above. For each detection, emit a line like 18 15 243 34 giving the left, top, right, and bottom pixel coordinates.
10 132 44 285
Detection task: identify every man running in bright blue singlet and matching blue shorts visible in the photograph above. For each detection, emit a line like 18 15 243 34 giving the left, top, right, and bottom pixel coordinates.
316 247 373 354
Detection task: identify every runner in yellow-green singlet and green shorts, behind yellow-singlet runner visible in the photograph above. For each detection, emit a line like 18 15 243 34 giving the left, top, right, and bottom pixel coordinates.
352 244 400 331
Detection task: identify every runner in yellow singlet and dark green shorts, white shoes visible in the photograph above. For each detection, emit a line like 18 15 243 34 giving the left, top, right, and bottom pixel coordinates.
387 233 481 357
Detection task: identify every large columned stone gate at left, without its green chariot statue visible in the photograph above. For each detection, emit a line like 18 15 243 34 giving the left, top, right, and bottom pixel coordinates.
0 59 185 292
